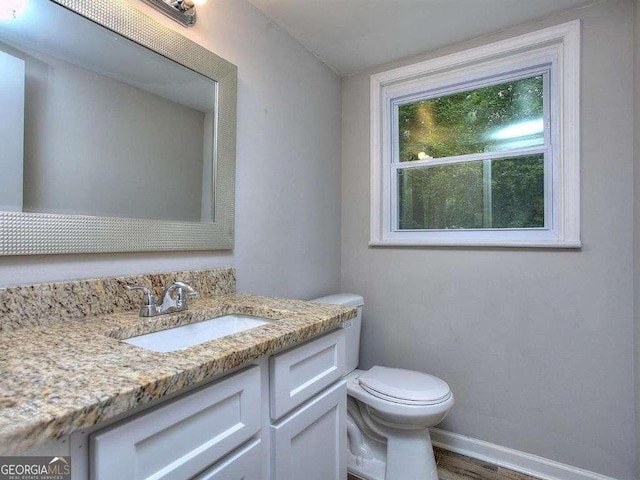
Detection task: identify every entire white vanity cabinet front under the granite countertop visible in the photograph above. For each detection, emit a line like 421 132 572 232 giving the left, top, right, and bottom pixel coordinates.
85 329 347 480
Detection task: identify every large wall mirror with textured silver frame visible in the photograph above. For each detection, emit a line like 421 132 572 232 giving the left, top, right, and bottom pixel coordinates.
0 0 237 254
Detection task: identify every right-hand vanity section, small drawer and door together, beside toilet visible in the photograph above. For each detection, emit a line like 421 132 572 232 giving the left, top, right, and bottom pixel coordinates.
270 329 347 480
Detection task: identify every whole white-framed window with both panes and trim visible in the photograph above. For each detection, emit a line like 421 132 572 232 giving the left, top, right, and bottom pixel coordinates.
371 21 580 247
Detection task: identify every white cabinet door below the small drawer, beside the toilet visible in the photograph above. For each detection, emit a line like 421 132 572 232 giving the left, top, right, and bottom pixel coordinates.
271 382 347 480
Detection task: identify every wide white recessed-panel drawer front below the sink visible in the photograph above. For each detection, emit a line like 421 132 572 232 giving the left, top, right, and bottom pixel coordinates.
90 366 261 480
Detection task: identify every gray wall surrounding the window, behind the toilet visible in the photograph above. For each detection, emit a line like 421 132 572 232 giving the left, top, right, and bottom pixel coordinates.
342 0 636 480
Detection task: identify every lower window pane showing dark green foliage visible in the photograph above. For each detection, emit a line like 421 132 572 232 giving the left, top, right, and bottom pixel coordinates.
398 154 544 230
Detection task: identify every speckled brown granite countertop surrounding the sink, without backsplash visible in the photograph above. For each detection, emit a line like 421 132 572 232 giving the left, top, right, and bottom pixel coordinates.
0 294 356 454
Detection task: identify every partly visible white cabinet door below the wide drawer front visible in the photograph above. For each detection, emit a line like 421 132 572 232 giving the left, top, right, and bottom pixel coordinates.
193 440 264 480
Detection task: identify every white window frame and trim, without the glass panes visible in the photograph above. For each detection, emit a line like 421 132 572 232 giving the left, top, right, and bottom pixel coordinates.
369 20 581 248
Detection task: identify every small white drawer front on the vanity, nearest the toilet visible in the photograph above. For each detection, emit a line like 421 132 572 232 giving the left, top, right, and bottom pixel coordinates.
269 329 345 420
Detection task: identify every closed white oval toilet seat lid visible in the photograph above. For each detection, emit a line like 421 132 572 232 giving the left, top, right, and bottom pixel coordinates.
358 366 451 406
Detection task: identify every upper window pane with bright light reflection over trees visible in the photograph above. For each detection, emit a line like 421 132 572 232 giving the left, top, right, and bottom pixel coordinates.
398 75 544 162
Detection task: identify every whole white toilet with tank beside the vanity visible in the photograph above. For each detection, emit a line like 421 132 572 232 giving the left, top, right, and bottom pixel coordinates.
311 293 453 480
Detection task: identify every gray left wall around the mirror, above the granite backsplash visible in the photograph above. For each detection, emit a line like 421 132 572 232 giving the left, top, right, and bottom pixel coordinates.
0 0 340 298
